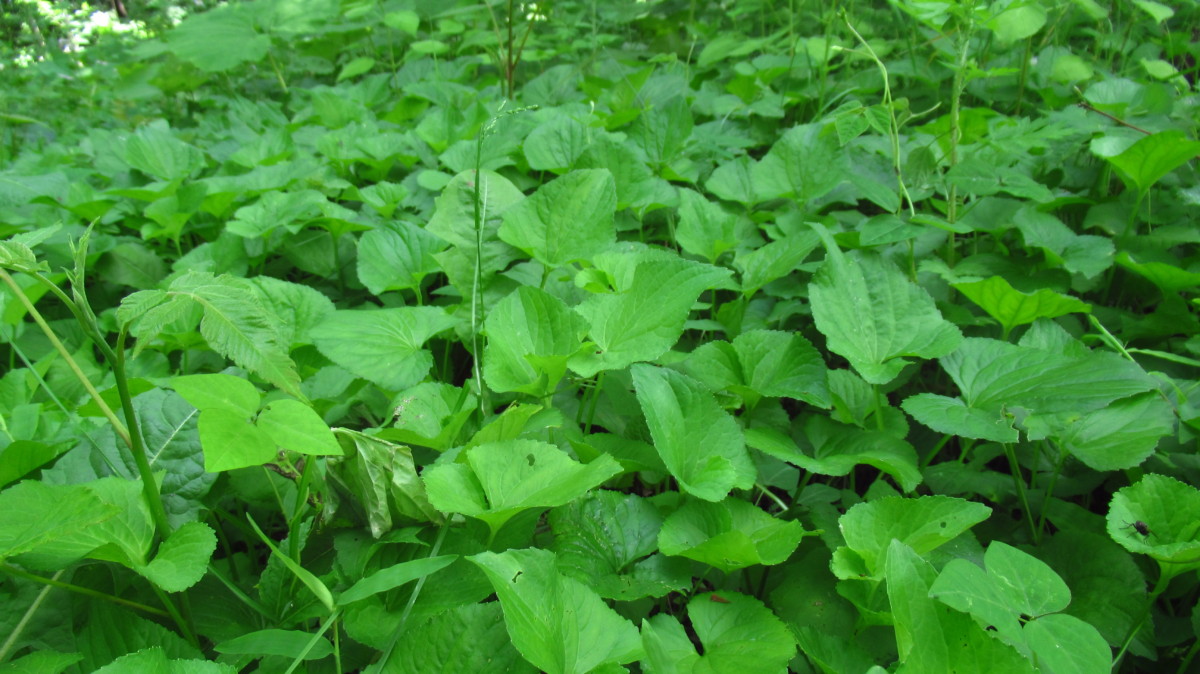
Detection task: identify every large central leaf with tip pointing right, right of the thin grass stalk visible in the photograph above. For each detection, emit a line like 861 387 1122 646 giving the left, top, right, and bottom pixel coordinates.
570 253 730 377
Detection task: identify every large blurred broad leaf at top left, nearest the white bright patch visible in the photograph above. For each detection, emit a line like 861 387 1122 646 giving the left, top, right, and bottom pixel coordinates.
167 5 271 72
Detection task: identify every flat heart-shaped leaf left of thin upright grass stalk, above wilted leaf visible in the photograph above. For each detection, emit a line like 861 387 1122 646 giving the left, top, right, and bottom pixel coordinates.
312 307 455 391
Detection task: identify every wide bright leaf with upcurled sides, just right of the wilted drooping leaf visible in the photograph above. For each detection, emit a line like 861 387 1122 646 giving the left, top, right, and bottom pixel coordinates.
422 440 620 536
